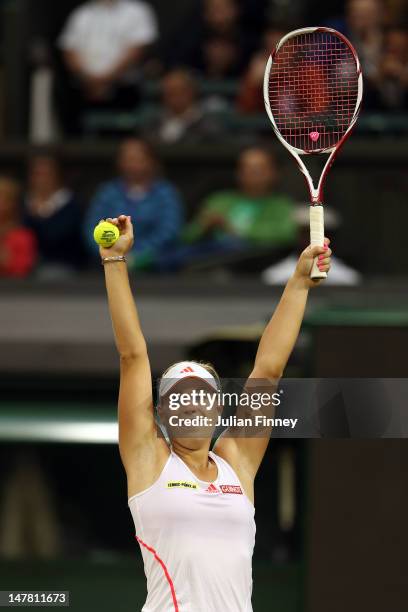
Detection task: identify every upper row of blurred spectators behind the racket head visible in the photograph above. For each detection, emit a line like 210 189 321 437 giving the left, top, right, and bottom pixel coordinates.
48 0 408 137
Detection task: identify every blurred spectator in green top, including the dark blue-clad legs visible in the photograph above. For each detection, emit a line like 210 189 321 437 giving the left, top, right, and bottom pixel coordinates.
157 146 297 270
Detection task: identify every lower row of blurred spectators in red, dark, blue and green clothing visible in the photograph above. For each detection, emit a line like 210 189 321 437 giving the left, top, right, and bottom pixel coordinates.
0 137 296 278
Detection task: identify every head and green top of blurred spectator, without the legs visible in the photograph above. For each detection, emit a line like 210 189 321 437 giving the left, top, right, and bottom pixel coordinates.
184 147 296 249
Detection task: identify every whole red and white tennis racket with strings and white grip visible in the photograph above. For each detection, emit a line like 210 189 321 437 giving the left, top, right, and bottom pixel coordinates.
264 27 363 280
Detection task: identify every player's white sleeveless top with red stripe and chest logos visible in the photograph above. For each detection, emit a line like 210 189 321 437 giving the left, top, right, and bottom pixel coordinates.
129 451 255 612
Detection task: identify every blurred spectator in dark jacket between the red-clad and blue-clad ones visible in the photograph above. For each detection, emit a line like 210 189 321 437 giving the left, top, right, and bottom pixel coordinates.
24 153 84 276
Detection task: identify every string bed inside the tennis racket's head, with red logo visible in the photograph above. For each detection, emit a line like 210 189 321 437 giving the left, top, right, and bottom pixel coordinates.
268 32 358 152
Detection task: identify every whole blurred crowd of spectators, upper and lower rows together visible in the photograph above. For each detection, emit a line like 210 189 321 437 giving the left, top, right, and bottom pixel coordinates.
0 0 402 282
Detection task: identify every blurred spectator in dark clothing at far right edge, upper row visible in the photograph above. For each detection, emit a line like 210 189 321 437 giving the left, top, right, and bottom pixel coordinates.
378 28 408 110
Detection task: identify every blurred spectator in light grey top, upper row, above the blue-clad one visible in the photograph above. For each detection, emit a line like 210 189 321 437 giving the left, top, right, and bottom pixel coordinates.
144 69 226 144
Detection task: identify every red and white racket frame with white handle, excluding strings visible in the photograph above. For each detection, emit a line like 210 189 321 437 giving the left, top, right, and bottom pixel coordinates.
263 27 363 280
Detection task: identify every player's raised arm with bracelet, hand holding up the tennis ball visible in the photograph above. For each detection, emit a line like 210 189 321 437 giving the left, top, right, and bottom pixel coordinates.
100 215 156 471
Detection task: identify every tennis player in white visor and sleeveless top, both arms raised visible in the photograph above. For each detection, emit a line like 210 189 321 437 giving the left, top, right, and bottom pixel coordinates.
100 216 331 612
